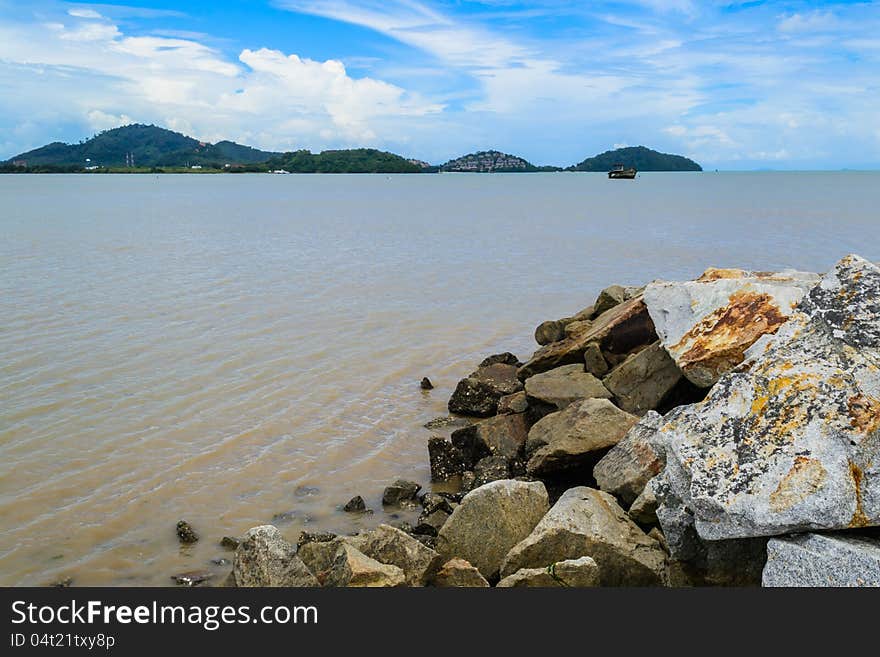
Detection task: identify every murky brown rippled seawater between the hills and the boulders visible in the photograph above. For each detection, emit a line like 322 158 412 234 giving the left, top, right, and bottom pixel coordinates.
0 173 880 585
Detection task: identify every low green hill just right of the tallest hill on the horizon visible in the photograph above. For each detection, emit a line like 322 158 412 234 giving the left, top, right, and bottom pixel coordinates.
266 148 423 173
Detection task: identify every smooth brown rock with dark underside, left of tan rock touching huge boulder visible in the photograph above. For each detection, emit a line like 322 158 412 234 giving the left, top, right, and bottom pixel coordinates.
526 399 639 476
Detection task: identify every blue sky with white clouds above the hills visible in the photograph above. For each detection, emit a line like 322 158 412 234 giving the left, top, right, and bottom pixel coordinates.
0 0 880 169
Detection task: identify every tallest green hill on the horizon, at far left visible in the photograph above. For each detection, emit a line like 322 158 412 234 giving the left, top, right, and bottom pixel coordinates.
9 123 278 167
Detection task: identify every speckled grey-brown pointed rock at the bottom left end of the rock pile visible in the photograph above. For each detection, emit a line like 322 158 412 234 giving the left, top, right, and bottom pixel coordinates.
232 525 318 587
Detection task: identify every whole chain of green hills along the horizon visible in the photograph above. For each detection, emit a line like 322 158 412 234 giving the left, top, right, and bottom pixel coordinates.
0 124 702 173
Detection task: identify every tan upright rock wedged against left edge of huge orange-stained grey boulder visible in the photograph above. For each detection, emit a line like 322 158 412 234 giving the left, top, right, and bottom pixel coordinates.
593 411 666 506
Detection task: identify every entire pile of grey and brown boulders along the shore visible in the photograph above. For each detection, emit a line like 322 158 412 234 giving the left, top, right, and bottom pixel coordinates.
215 256 880 587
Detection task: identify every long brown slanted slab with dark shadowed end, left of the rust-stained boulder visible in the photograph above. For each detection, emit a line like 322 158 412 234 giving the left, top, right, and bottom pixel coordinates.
517 297 657 381
